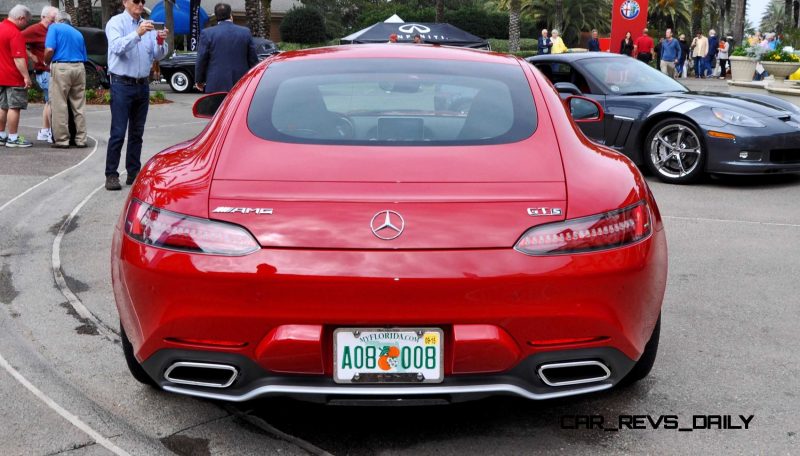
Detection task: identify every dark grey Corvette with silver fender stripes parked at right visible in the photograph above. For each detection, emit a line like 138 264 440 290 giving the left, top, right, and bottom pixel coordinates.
527 52 800 184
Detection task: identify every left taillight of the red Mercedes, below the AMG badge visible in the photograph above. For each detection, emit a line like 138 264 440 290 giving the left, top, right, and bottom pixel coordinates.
125 199 259 256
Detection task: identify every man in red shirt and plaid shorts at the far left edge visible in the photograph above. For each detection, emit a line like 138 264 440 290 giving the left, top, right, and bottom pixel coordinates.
0 5 32 147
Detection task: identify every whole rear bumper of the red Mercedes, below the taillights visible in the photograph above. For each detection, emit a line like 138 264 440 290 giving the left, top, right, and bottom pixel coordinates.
112 226 667 401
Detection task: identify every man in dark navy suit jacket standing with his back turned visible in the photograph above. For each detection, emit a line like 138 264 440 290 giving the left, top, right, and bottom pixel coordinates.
195 3 258 93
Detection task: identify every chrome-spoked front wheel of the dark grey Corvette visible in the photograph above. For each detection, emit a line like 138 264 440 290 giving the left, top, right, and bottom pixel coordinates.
644 119 705 184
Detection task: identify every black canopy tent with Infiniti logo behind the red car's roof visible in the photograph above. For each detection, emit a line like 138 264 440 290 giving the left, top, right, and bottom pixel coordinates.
340 21 489 49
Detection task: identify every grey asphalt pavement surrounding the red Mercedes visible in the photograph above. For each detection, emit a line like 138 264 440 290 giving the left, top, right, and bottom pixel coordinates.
0 81 800 455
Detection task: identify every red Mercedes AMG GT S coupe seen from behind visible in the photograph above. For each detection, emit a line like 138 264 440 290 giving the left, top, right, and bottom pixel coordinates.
111 44 667 403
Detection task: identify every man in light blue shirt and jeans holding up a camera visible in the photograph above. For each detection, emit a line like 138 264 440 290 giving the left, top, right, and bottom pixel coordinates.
105 0 167 190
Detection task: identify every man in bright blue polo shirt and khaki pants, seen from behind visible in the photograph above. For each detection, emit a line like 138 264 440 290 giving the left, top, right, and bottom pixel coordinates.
44 11 86 149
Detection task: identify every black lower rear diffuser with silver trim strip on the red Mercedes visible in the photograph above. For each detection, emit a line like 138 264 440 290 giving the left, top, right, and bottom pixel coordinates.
143 347 635 403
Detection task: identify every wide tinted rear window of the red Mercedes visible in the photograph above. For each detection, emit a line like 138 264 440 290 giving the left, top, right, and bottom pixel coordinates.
247 59 536 146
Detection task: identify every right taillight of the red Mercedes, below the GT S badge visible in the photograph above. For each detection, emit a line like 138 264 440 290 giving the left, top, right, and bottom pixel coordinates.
514 201 652 255
